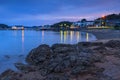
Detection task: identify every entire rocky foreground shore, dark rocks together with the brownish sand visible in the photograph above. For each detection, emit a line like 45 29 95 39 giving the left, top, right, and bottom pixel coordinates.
0 40 120 80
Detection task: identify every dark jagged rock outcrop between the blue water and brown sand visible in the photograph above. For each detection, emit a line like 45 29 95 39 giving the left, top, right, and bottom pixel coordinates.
24 42 117 80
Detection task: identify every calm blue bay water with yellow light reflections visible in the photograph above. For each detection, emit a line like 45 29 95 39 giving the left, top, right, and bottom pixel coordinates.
0 30 96 71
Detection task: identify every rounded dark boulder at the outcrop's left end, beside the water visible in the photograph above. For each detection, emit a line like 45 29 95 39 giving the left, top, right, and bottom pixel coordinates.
26 44 52 65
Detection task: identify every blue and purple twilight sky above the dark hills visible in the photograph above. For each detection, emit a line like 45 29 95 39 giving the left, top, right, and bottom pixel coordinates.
0 0 120 26
